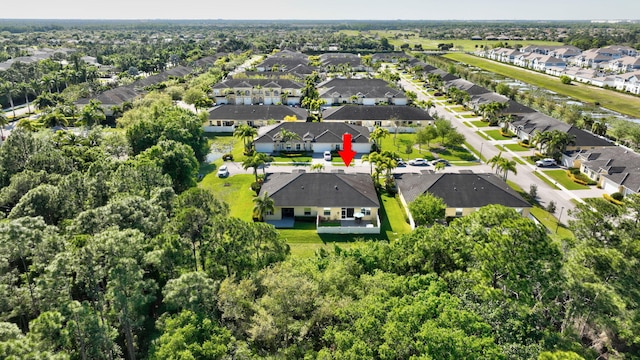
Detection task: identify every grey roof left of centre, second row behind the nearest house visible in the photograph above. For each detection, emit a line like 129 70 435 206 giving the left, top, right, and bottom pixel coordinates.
209 105 307 120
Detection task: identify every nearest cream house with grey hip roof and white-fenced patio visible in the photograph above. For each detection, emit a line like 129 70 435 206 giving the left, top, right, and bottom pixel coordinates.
259 172 380 234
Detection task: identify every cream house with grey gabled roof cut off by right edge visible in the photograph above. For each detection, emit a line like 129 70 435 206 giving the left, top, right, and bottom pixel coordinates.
563 146 640 195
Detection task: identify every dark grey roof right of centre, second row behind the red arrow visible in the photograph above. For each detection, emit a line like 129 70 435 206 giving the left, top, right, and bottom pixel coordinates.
322 105 433 121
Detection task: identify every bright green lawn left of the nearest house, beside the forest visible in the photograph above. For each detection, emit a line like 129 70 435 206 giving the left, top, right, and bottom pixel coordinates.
198 174 255 221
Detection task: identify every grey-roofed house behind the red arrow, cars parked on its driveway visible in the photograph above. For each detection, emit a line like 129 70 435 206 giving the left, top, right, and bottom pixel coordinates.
254 122 371 154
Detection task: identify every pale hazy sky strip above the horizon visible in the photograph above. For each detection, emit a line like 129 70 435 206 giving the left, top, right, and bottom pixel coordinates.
0 0 640 20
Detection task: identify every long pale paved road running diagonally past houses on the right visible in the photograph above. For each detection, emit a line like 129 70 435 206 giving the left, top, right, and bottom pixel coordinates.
400 76 604 222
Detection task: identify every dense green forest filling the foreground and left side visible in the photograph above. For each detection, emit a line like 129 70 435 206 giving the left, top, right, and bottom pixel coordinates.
0 97 640 359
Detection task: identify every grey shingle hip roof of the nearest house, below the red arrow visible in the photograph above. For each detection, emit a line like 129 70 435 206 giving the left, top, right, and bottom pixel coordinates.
260 173 380 208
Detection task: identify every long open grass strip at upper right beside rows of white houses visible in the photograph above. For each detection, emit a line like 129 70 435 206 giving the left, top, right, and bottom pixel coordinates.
445 53 640 118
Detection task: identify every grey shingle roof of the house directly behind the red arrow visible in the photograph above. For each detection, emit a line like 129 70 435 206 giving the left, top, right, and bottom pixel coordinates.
255 122 369 143
